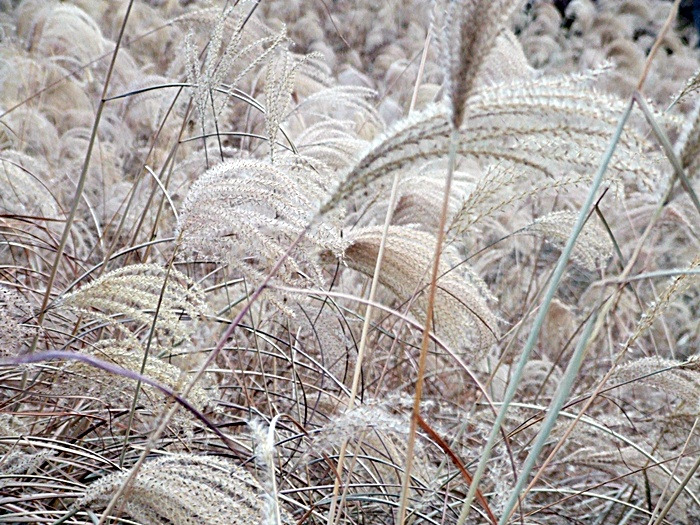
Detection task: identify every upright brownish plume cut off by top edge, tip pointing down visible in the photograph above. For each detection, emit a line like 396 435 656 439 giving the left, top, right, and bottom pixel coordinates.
442 0 518 128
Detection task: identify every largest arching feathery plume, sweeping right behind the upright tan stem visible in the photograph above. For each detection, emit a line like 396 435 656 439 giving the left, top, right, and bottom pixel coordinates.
321 70 655 213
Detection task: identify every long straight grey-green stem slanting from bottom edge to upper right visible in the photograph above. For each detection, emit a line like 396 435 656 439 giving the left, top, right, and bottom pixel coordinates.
457 99 634 525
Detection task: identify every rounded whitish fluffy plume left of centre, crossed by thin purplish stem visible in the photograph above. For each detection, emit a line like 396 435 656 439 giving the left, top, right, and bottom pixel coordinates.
178 159 336 311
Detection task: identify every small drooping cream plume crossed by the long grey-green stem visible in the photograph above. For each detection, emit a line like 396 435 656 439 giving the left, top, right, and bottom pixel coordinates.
522 211 613 271
